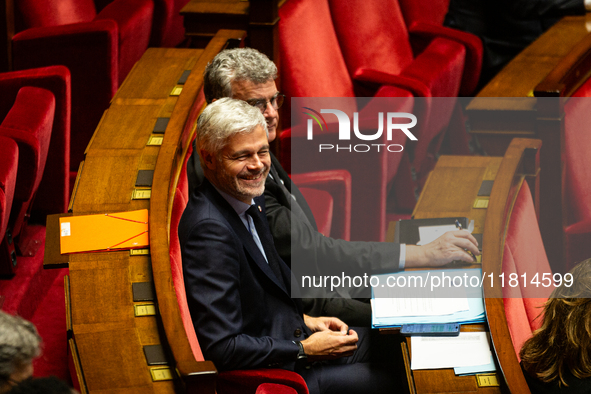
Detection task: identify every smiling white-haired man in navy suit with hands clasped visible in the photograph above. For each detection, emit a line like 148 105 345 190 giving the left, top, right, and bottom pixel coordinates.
178 98 404 394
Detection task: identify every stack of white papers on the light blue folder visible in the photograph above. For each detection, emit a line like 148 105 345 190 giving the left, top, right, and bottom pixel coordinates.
371 268 485 328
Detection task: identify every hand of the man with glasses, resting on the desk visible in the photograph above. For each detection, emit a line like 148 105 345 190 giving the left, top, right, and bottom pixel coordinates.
406 230 480 267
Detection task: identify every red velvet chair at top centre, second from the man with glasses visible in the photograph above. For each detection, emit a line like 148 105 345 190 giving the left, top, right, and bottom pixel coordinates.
329 0 466 179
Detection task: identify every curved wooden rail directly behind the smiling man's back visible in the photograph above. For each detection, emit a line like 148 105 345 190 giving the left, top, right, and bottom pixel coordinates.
150 30 243 393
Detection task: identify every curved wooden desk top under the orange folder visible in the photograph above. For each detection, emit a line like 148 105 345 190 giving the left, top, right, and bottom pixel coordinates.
59 32 243 394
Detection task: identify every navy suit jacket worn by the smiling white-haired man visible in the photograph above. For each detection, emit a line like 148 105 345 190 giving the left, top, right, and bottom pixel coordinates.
179 180 310 370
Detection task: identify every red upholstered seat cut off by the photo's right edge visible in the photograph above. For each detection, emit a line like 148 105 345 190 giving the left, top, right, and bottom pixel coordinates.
557 80 591 271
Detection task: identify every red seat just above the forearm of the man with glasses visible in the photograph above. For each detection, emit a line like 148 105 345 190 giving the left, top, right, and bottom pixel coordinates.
292 170 351 241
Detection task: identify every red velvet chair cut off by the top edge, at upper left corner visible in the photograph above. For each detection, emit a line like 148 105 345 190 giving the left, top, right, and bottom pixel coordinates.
12 0 154 183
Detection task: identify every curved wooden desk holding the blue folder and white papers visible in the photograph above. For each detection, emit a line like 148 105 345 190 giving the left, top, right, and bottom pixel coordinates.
407 139 541 393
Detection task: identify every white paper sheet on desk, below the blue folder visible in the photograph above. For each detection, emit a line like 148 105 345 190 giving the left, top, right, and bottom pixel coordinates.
411 332 493 370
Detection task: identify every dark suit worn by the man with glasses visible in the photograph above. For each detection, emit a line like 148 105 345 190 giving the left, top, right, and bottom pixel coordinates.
187 143 400 326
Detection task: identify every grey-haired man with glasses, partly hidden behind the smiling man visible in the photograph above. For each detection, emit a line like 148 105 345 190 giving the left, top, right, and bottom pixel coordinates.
187 48 479 326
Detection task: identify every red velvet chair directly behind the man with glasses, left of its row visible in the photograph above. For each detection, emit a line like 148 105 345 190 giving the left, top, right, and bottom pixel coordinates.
279 0 413 241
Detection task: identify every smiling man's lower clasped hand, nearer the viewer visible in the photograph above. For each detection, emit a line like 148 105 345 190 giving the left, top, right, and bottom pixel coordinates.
302 330 359 361
